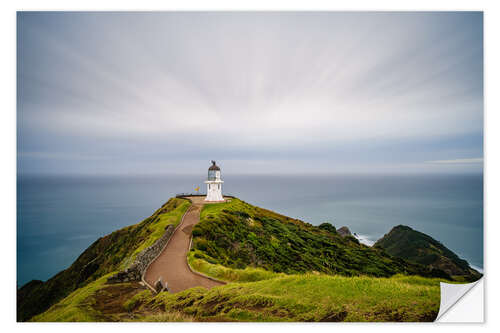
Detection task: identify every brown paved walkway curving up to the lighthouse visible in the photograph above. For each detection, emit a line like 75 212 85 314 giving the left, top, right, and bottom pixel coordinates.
144 197 224 293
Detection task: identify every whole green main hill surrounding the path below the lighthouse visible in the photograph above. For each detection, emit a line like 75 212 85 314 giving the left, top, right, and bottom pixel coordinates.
18 198 472 321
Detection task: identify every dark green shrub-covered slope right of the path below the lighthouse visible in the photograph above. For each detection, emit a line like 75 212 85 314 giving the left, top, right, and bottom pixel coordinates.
193 199 449 278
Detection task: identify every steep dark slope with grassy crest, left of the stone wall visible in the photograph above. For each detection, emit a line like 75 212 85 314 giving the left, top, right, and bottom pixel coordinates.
17 198 189 321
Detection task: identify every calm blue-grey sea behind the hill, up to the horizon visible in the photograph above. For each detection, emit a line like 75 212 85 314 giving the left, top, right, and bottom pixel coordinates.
17 175 483 285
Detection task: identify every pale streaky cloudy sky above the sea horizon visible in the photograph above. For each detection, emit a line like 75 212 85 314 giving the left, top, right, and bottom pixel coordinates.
17 12 483 175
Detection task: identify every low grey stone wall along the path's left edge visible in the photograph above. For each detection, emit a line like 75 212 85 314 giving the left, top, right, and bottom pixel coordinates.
107 224 175 283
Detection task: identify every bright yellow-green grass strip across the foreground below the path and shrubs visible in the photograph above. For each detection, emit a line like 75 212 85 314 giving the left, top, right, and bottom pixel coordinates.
33 264 440 321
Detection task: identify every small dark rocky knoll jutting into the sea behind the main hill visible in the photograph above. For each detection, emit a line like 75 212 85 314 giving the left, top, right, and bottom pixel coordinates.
374 225 481 281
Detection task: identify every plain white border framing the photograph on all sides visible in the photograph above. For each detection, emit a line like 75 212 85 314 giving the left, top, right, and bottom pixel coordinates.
0 0 500 333
